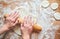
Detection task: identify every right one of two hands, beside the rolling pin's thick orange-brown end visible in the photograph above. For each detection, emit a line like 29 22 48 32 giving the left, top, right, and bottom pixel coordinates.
21 16 34 35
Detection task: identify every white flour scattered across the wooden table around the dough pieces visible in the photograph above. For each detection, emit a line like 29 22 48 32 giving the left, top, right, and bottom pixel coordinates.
0 0 58 39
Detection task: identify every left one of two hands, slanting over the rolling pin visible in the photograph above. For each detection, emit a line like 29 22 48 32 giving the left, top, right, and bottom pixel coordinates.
3 12 19 29
